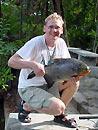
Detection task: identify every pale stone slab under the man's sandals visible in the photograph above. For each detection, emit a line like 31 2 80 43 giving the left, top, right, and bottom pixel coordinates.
6 113 98 130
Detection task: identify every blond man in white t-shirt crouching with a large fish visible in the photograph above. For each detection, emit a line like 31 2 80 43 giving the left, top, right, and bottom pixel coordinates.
8 13 79 128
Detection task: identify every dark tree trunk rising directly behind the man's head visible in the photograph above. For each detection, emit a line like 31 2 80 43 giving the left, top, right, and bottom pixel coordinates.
52 0 69 46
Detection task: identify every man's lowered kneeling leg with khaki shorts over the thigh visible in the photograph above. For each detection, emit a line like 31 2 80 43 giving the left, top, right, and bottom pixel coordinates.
19 87 65 122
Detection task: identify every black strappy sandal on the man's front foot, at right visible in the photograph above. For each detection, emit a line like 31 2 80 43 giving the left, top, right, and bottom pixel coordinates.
54 114 77 128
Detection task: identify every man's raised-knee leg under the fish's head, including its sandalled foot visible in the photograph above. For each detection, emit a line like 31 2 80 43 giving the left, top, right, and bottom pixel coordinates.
50 79 79 128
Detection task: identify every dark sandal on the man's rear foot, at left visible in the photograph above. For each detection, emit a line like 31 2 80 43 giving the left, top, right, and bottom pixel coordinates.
18 101 31 123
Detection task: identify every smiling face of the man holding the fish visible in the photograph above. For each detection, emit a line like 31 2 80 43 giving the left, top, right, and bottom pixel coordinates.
44 19 63 42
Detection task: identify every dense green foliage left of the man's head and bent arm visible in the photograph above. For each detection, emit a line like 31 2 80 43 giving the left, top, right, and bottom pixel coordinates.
0 0 43 91
